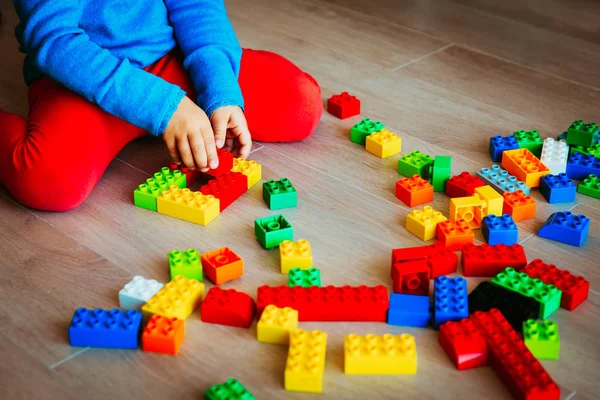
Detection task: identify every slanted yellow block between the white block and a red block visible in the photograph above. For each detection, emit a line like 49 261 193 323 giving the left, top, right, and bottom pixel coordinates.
142 275 204 320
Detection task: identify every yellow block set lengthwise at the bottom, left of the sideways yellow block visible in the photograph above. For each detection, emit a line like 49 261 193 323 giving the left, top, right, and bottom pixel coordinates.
284 329 327 393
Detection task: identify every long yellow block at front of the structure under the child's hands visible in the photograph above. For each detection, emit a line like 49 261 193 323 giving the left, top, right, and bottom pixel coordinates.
156 185 221 225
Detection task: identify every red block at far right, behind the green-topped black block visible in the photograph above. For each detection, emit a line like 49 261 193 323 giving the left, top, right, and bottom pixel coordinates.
521 259 590 311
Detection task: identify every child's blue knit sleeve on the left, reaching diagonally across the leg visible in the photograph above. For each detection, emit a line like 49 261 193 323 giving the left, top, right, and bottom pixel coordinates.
14 0 185 135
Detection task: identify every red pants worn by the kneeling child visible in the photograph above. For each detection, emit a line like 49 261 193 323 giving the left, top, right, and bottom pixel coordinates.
0 49 323 211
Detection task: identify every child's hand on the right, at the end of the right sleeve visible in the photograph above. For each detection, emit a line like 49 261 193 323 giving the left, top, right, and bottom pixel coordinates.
210 106 252 158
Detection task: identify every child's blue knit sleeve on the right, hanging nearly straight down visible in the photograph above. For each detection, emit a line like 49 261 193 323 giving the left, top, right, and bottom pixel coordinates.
165 0 244 117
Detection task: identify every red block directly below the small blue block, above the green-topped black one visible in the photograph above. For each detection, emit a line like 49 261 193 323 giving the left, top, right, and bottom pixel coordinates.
461 244 527 277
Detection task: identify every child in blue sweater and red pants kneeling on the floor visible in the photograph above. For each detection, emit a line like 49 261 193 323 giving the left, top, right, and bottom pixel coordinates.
0 0 322 211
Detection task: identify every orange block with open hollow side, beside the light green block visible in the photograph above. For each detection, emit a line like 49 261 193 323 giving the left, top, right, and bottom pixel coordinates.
201 247 244 285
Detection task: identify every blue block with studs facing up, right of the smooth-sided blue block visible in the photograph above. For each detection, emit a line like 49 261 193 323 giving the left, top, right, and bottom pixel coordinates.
433 276 469 328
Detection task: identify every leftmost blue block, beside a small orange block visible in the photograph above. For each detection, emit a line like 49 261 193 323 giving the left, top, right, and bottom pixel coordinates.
69 308 142 349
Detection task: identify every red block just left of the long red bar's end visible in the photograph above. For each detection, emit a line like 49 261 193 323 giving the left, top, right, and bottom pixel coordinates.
200 286 256 328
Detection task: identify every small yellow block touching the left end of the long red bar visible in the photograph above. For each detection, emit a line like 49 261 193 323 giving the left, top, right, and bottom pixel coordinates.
256 304 298 344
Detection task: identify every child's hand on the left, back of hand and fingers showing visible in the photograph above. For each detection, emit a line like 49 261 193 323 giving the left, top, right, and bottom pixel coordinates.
163 97 219 172
